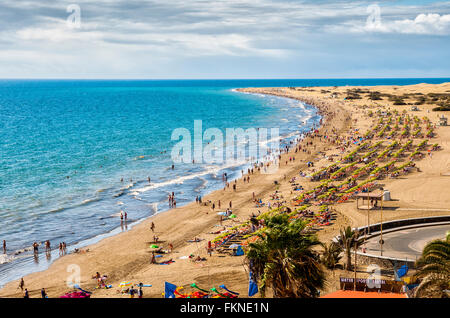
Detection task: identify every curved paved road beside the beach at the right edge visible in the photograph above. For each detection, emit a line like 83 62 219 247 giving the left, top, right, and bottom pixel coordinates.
366 224 450 260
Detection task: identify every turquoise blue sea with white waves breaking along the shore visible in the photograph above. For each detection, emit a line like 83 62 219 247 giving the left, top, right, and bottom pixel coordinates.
0 78 450 287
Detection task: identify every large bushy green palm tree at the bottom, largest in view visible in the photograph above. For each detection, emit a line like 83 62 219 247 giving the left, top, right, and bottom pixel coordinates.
246 214 325 298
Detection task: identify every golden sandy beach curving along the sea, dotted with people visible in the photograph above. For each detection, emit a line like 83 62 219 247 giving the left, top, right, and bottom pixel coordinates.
0 83 450 298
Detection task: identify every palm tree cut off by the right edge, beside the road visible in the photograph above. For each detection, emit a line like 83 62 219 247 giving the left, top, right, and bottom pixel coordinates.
414 234 450 298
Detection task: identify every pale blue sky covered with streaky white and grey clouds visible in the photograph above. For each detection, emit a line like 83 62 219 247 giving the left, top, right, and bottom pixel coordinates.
0 0 450 79
